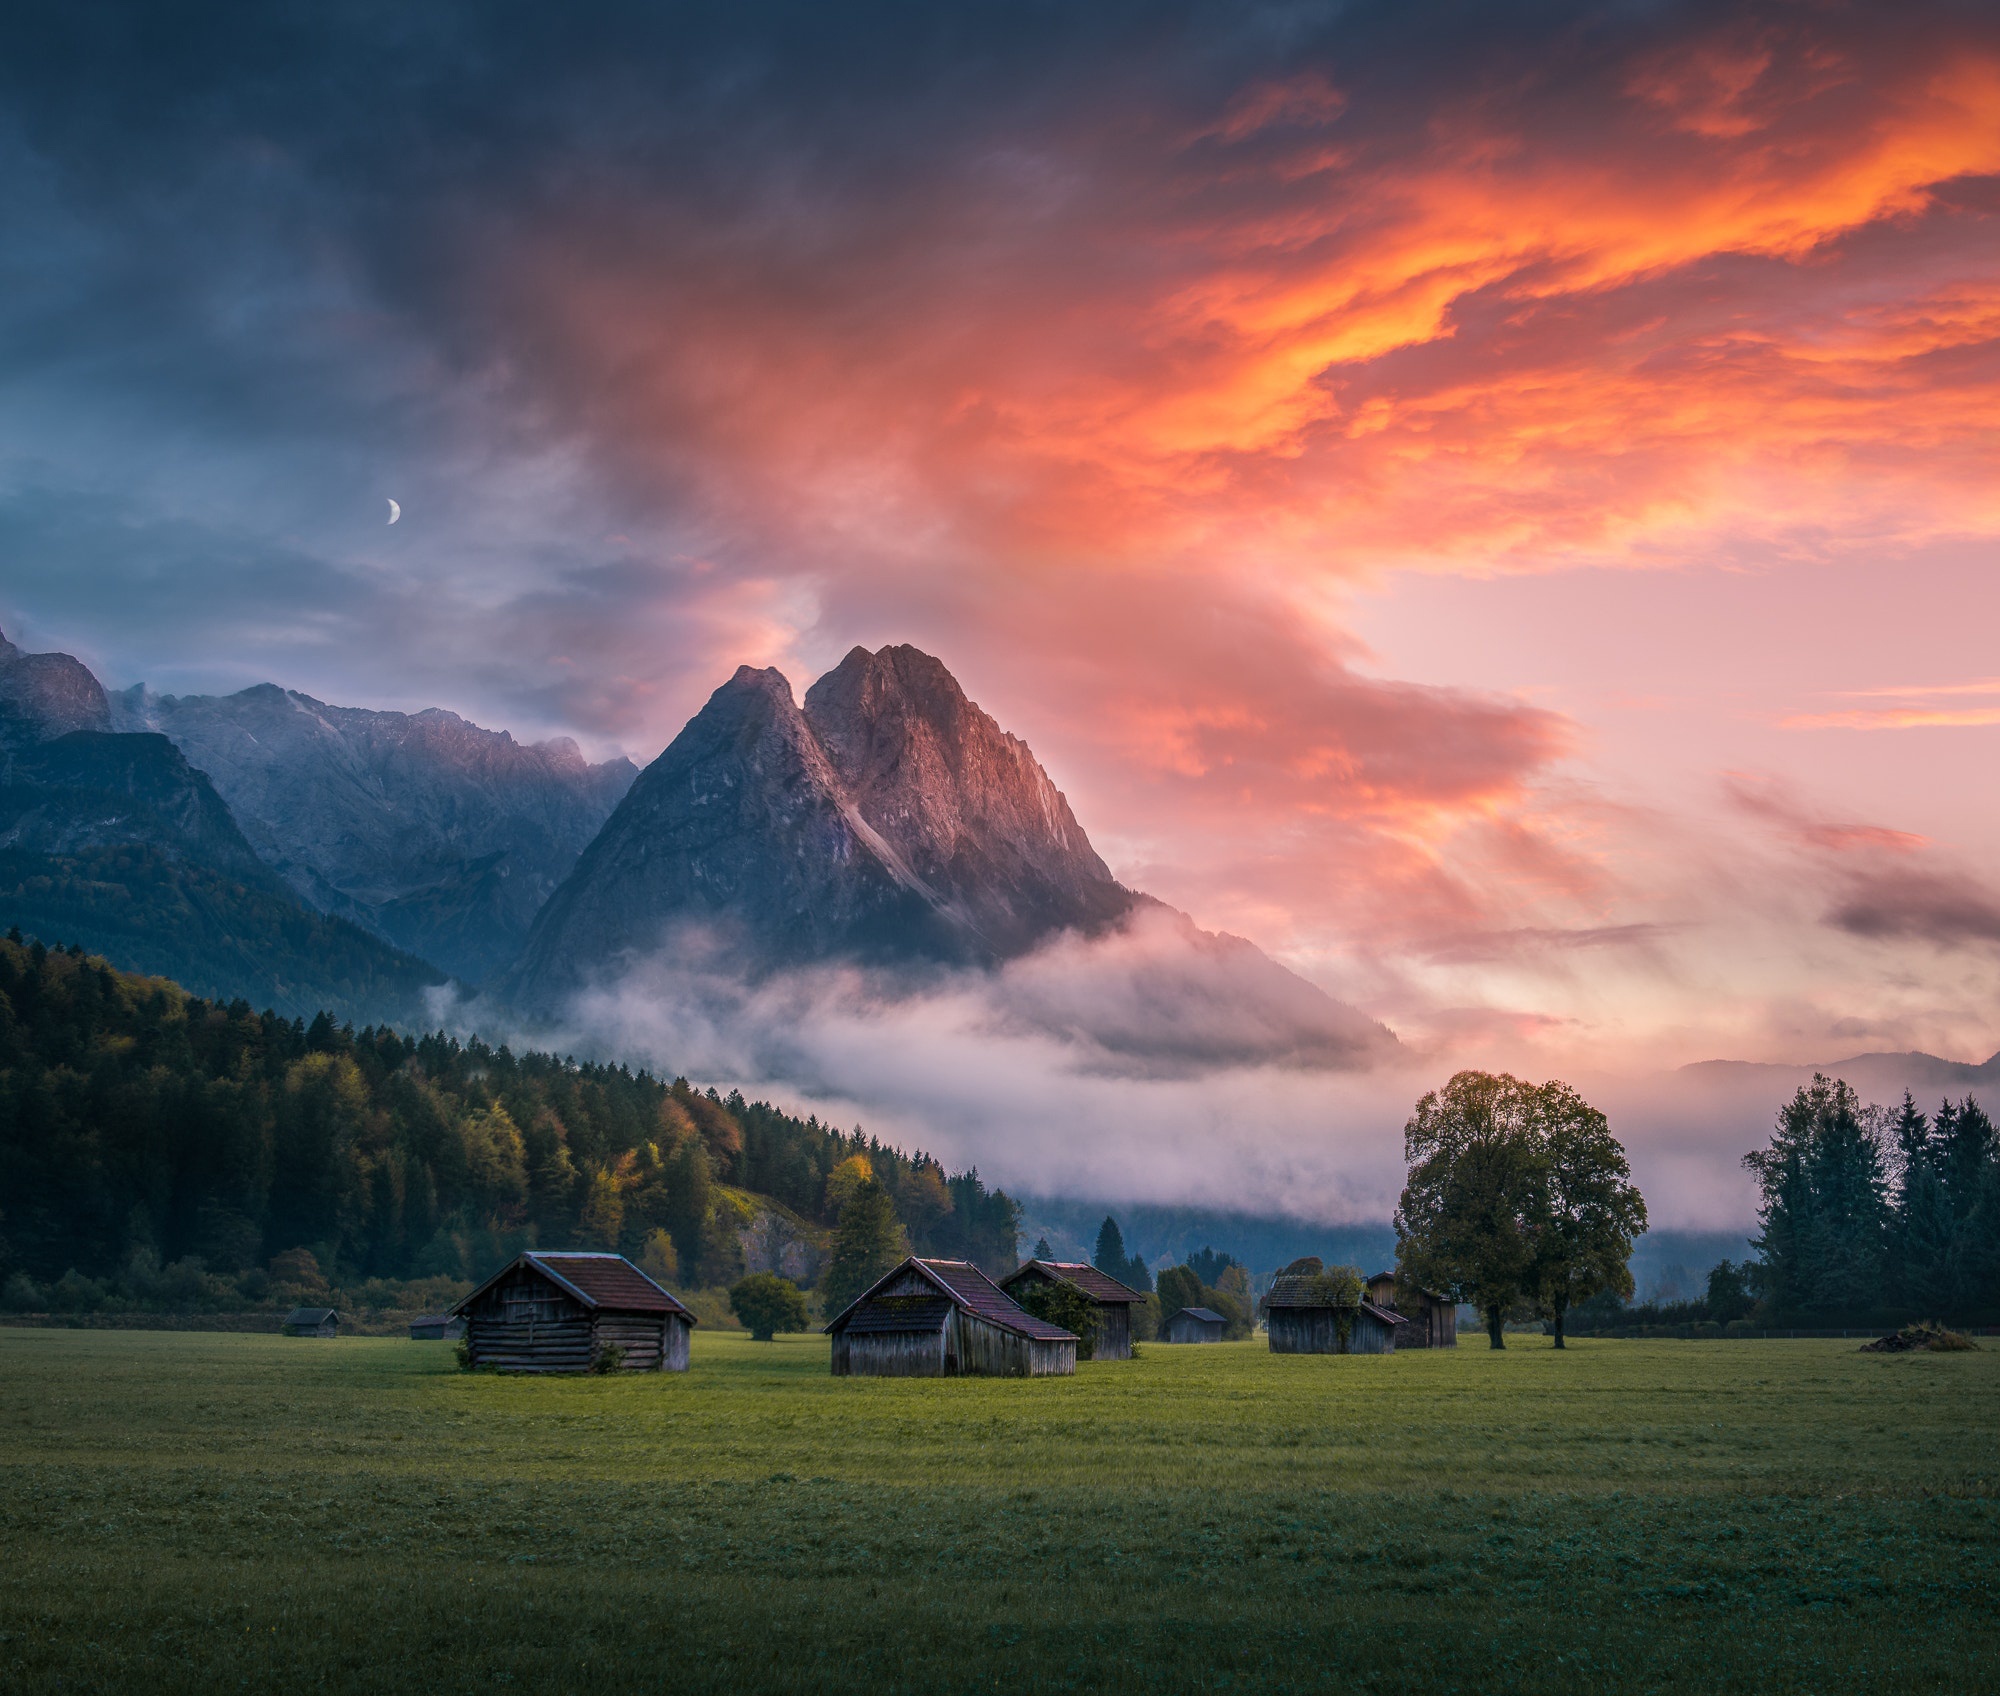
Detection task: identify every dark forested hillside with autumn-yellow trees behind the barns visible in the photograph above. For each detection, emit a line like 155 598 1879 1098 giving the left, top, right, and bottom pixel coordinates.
0 932 1018 1306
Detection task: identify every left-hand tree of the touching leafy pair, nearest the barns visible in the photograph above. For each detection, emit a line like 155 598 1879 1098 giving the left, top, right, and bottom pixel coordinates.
1396 1072 1540 1348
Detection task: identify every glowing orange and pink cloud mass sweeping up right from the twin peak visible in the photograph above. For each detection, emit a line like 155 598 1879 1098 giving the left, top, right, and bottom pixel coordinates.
434 8 2000 1008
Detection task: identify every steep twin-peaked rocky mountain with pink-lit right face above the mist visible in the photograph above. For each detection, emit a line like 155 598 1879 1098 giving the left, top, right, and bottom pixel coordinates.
506 648 1134 1006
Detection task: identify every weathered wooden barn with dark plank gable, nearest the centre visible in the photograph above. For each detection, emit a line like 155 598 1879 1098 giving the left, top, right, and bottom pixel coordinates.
826 1254 1076 1378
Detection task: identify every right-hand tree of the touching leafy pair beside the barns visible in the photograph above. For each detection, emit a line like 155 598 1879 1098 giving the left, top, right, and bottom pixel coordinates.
1522 1082 1646 1348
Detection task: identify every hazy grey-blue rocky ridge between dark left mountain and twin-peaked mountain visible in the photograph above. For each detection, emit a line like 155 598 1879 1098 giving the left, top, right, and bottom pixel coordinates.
110 684 634 982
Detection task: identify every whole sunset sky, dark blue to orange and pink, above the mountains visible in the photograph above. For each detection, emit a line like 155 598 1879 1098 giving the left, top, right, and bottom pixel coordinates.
0 0 2000 1216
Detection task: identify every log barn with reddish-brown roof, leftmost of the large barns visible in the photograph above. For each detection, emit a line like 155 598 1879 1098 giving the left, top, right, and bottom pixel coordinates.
452 1250 694 1372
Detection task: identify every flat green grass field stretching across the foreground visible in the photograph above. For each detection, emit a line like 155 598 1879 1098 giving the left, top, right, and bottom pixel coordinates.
0 1330 2000 1696
